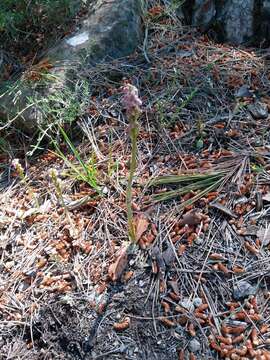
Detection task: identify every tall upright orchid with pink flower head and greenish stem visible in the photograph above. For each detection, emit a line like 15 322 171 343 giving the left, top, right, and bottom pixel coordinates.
122 84 142 242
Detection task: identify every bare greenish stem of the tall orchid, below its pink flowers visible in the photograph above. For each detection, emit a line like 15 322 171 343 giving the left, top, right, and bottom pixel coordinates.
126 119 138 242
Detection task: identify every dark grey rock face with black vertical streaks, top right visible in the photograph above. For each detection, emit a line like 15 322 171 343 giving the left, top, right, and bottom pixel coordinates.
180 0 270 45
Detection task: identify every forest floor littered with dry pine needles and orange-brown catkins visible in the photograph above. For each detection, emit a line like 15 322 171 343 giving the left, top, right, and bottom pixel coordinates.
0 2 270 360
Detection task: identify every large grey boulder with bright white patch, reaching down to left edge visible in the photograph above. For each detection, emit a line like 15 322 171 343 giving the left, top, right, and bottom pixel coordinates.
0 0 142 134
